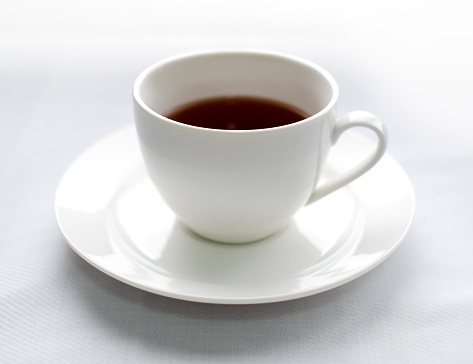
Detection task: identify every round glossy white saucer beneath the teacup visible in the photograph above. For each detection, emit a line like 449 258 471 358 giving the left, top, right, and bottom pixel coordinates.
56 128 414 304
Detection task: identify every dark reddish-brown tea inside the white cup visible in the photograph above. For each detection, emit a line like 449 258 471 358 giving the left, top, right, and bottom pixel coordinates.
167 96 309 130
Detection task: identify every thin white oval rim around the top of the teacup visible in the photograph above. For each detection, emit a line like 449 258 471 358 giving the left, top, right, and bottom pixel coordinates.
133 49 339 134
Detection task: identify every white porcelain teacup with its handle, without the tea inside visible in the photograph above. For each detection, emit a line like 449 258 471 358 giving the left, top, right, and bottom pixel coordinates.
133 51 387 243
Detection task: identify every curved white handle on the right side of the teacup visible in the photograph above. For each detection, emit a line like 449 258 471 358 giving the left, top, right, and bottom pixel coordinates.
306 111 388 205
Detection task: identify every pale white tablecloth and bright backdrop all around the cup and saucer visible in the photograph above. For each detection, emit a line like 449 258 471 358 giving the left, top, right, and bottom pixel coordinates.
0 0 473 363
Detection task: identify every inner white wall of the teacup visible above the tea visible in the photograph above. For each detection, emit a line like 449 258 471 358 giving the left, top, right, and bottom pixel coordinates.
134 51 338 120
